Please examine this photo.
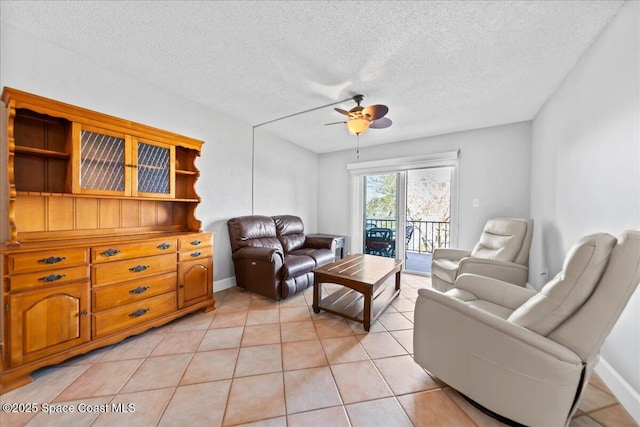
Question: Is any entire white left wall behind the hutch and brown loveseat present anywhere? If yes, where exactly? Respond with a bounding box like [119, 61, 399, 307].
[0, 23, 318, 290]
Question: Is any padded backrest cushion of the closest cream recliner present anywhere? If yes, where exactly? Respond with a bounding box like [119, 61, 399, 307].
[509, 233, 616, 336]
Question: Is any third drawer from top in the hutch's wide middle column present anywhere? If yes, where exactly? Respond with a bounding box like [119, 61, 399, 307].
[91, 273, 176, 313]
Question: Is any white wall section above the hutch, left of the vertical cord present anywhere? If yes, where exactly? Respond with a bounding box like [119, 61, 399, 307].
[0, 23, 252, 290]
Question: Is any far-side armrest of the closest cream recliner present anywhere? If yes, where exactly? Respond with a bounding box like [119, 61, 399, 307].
[454, 273, 537, 310]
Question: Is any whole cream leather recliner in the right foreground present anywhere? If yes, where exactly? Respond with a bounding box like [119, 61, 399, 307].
[413, 231, 640, 427]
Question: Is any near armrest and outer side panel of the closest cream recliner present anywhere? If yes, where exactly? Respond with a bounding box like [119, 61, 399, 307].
[413, 289, 585, 426]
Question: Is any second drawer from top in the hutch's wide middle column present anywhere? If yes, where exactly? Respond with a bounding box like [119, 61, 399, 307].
[91, 253, 177, 286]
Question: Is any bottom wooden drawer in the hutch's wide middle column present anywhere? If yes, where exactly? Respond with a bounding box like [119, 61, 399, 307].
[92, 292, 176, 338]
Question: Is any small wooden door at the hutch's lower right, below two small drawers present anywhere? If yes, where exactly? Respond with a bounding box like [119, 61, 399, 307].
[178, 258, 213, 308]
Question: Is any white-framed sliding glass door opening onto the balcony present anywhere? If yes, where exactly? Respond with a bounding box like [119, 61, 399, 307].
[347, 151, 460, 275]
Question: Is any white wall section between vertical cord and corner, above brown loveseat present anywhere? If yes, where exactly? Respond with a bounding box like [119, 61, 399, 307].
[254, 126, 318, 234]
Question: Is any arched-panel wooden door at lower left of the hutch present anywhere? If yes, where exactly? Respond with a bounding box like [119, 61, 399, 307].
[9, 281, 89, 366]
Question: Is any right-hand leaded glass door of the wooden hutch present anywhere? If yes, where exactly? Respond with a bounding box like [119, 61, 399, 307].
[134, 141, 175, 197]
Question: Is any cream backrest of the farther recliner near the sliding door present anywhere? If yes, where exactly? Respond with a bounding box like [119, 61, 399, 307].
[471, 218, 533, 266]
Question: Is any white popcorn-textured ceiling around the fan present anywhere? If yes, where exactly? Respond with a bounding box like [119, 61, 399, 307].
[0, 0, 623, 153]
